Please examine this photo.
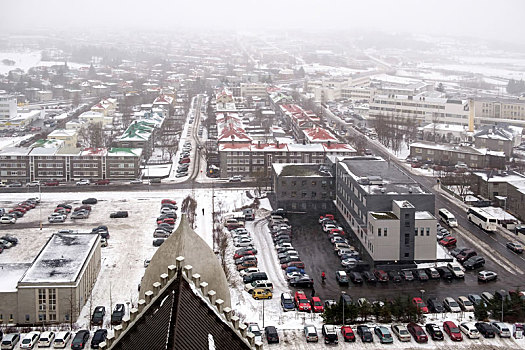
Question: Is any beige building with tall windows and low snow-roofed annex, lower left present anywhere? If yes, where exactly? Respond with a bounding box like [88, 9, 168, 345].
[0, 234, 101, 325]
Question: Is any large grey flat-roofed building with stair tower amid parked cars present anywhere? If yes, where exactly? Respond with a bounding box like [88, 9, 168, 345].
[335, 156, 436, 263]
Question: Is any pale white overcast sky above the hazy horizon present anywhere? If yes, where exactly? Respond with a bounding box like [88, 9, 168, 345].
[4, 0, 525, 41]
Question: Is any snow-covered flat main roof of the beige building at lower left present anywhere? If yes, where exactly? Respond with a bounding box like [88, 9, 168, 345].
[20, 233, 99, 283]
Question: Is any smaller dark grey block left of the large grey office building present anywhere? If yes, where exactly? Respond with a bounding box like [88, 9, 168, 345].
[272, 163, 335, 213]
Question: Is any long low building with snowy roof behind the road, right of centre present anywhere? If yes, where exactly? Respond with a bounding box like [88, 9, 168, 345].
[410, 141, 505, 169]
